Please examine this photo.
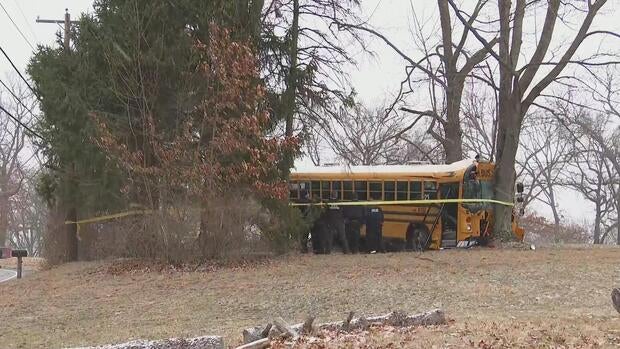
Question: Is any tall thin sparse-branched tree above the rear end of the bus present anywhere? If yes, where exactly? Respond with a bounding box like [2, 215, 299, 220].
[259, 0, 364, 171]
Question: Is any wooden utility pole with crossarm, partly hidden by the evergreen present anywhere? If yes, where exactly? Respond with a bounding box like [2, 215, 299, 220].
[37, 9, 79, 261]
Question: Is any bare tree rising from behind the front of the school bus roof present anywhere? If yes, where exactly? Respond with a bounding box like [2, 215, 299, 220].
[338, 0, 497, 162]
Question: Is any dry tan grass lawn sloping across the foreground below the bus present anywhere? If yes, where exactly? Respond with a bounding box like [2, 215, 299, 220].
[0, 248, 620, 348]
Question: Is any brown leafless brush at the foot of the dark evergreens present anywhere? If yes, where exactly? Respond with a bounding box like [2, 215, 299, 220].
[44, 192, 309, 264]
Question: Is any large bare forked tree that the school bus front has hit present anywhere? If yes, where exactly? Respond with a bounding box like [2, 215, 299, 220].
[447, 0, 608, 233]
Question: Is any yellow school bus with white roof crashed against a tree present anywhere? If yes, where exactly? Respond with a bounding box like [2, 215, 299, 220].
[290, 159, 524, 249]
